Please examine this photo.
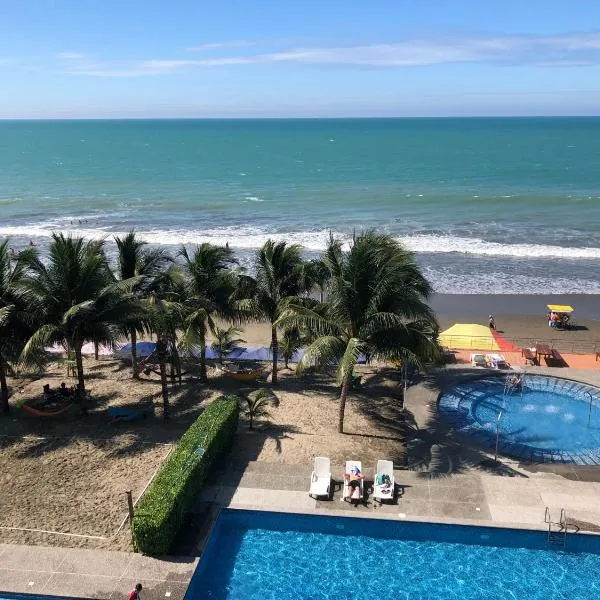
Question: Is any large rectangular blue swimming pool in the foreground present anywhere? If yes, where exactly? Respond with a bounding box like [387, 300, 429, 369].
[185, 510, 600, 600]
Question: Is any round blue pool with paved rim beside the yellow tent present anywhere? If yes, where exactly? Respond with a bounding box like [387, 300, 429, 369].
[438, 375, 600, 465]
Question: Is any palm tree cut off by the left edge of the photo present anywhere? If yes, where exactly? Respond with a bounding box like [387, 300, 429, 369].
[0, 240, 35, 413]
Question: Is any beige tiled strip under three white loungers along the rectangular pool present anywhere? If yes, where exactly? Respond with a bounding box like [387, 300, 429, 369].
[200, 462, 600, 531]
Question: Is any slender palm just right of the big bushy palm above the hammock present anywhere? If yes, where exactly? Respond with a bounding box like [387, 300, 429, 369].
[115, 230, 169, 379]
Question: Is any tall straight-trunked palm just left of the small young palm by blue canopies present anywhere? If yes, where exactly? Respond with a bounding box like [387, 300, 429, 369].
[179, 243, 238, 380]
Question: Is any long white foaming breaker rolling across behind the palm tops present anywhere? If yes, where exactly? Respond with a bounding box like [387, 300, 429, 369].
[0, 223, 600, 260]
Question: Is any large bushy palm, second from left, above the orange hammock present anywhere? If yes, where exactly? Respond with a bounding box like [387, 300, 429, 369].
[22, 233, 141, 399]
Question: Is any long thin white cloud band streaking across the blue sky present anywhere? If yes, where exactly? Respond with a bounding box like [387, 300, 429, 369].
[63, 32, 600, 77]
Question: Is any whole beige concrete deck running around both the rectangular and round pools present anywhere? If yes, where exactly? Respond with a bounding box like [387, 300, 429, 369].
[0, 366, 600, 600]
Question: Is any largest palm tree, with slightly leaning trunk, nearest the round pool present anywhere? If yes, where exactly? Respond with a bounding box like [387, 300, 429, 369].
[278, 231, 438, 433]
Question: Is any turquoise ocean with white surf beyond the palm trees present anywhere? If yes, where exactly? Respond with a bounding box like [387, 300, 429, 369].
[0, 118, 600, 294]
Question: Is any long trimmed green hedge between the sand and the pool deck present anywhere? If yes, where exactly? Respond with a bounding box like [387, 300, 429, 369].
[132, 396, 239, 556]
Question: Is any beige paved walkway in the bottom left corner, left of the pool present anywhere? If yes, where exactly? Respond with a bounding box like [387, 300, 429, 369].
[0, 544, 198, 600]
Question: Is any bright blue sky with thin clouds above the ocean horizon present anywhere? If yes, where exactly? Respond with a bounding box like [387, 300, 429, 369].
[0, 0, 600, 118]
